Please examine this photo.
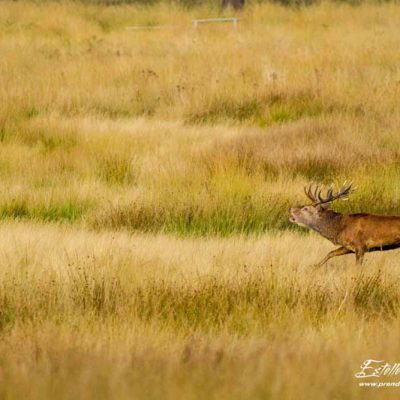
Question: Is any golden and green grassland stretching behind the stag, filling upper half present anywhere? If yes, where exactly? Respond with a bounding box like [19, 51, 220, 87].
[0, 2, 400, 234]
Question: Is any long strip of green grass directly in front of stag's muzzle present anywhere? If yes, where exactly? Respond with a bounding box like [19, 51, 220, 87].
[90, 196, 293, 236]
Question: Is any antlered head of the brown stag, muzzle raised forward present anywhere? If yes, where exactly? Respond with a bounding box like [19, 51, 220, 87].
[289, 183, 353, 232]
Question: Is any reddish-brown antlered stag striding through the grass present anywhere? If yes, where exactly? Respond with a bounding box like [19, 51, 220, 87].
[289, 184, 400, 266]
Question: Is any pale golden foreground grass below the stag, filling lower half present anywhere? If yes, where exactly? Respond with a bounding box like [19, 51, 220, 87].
[0, 222, 400, 399]
